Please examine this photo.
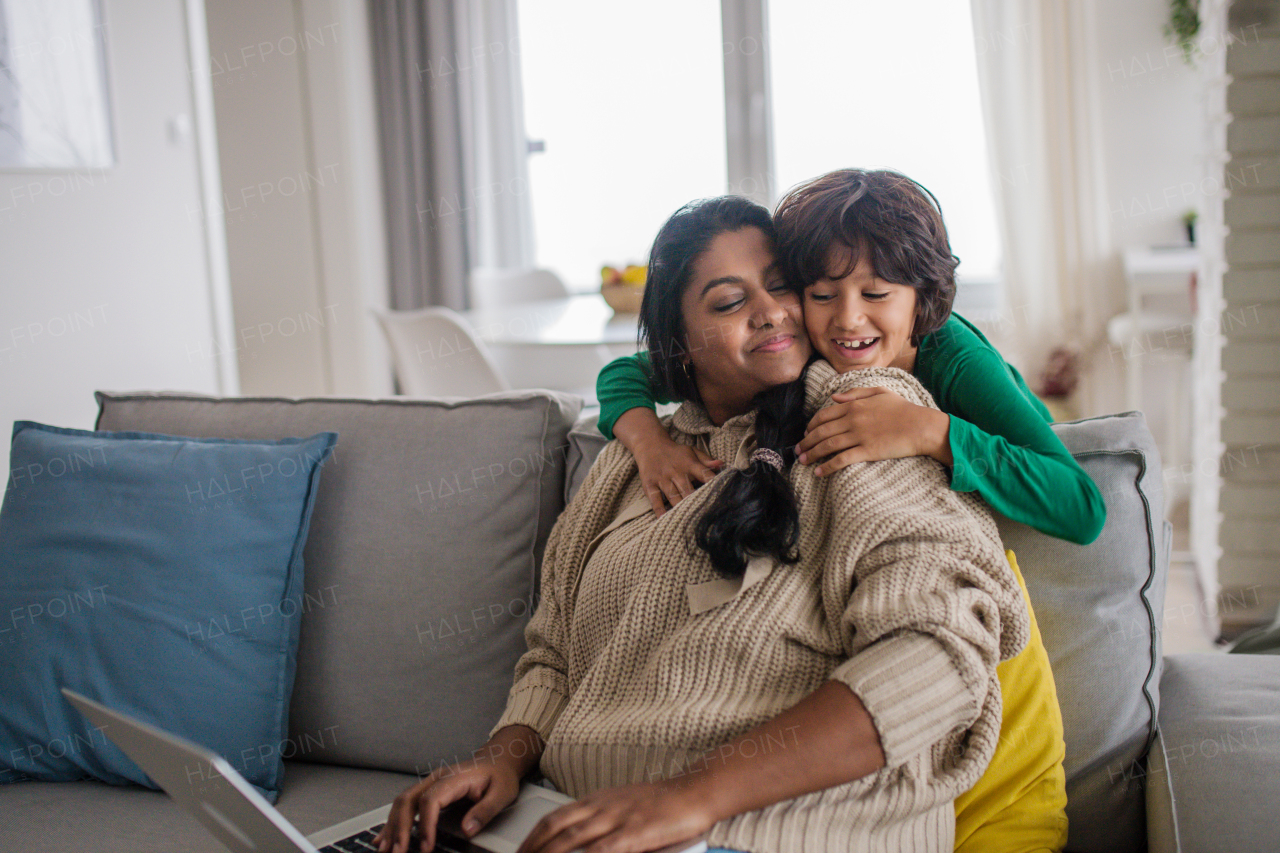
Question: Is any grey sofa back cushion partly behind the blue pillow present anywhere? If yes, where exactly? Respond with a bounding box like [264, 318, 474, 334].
[99, 392, 580, 774]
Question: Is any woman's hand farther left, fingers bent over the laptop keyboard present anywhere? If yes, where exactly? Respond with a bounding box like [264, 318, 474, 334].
[374, 758, 520, 853]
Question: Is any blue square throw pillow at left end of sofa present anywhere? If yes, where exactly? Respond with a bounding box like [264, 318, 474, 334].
[0, 421, 338, 802]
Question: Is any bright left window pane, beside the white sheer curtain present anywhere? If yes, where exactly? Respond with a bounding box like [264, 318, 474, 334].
[517, 0, 727, 289]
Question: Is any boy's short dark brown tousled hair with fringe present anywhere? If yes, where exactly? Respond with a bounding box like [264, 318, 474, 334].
[773, 169, 960, 346]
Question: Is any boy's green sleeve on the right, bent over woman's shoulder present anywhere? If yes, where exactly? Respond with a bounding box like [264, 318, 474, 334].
[931, 322, 1107, 544]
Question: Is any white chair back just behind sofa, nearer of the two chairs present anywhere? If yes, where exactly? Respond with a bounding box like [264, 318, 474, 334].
[374, 307, 509, 397]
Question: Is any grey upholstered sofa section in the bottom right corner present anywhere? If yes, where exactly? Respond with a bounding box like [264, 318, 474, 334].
[1146, 653, 1280, 853]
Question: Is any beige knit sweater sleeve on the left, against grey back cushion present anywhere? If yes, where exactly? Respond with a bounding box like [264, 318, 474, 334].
[489, 442, 635, 740]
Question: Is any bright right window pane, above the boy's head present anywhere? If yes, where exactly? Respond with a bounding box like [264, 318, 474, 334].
[769, 0, 1000, 285]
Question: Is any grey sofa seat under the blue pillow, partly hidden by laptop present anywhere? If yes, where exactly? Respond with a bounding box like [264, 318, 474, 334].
[0, 761, 417, 853]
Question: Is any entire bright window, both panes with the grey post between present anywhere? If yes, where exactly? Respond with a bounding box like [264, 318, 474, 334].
[517, 0, 1000, 302]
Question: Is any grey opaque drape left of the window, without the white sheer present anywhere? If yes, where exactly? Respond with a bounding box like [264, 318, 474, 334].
[369, 0, 476, 311]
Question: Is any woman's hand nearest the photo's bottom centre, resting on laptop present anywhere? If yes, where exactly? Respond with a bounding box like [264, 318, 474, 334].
[516, 781, 716, 853]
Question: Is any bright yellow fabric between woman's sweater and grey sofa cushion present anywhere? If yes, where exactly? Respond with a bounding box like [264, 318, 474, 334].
[956, 551, 1066, 853]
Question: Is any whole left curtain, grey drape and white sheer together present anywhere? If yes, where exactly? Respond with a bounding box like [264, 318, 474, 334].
[369, 0, 534, 310]
